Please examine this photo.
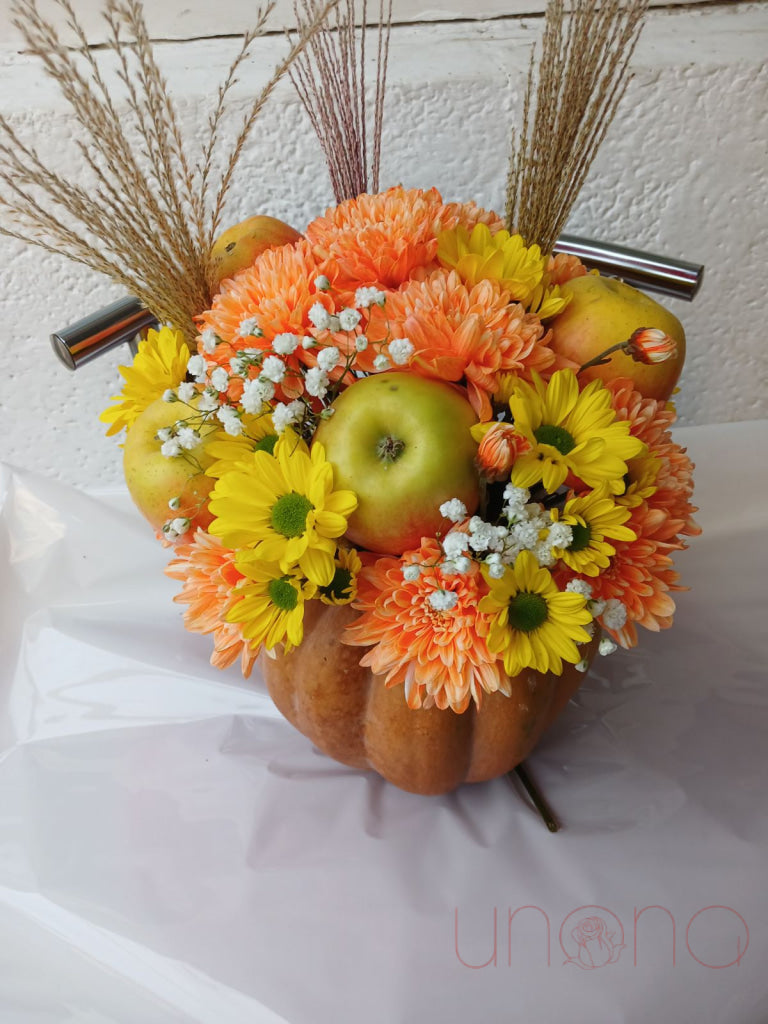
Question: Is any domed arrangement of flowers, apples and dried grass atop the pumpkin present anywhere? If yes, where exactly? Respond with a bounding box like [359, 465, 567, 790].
[0, 0, 698, 815]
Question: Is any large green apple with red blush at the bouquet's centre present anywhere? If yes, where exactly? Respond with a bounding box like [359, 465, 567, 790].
[314, 372, 480, 555]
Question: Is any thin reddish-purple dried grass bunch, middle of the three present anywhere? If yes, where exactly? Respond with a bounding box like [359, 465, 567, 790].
[290, 0, 392, 203]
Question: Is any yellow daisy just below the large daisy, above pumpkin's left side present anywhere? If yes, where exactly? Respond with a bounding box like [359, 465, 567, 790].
[226, 551, 317, 652]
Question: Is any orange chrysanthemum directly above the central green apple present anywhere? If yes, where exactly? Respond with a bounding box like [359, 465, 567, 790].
[366, 269, 555, 420]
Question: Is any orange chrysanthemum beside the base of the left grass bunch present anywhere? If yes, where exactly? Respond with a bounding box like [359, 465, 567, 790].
[199, 239, 323, 367]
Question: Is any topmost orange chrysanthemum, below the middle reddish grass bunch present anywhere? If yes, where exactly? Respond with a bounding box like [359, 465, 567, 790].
[306, 185, 503, 293]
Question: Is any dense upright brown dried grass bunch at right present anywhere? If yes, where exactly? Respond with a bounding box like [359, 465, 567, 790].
[507, 0, 648, 252]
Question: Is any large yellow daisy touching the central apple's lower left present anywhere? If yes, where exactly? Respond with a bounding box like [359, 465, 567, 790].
[209, 430, 357, 587]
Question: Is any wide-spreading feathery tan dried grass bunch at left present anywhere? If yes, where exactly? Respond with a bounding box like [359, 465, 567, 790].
[0, 0, 339, 337]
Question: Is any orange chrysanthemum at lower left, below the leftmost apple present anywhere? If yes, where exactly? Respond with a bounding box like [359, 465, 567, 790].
[165, 529, 258, 679]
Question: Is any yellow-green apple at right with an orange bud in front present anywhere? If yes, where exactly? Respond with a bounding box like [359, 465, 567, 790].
[551, 273, 685, 401]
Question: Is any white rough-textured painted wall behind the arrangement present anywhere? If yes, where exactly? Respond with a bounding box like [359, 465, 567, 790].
[0, 3, 768, 486]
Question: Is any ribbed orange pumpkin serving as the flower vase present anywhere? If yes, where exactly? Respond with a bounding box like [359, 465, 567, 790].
[261, 601, 598, 795]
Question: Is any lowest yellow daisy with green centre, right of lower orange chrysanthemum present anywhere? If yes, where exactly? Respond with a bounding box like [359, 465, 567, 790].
[478, 551, 592, 677]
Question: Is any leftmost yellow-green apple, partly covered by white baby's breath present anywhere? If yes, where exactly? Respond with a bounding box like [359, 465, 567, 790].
[123, 398, 217, 530]
